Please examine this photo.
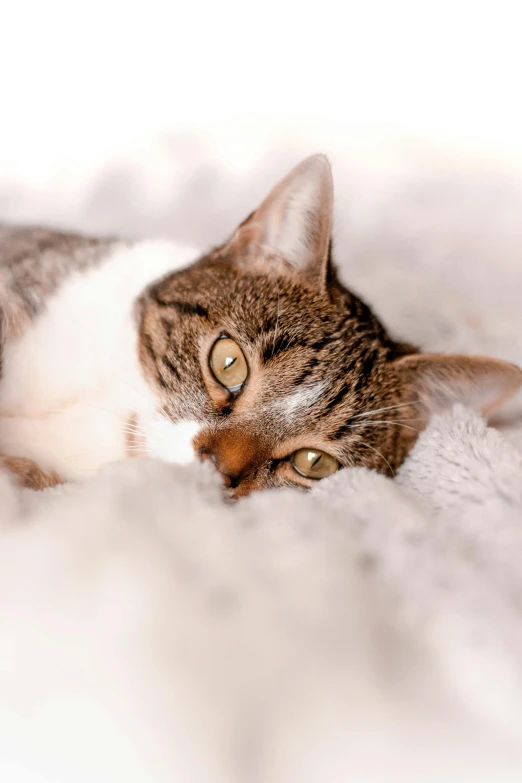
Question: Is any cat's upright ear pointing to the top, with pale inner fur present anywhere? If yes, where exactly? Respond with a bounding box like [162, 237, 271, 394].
[227, 155, 333, 288]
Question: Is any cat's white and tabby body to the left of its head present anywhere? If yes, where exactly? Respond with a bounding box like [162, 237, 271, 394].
[0, 226, 198, 478]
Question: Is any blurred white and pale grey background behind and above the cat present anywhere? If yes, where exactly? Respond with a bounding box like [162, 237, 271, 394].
[0, 0, 522, 361]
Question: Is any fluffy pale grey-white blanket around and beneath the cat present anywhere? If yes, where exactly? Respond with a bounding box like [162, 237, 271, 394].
[0, 136, 522, 783]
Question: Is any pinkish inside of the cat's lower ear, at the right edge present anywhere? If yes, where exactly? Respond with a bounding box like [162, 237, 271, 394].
[395, 354, 522, 415]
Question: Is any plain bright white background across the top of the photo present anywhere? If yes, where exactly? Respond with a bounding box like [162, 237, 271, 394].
[0, 0, 522, 187]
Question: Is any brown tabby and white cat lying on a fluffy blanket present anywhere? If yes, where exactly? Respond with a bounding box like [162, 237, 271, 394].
[0, 155, 522, 499]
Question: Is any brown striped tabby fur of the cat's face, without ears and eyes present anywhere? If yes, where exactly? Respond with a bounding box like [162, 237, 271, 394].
[140, 249, 418, 495]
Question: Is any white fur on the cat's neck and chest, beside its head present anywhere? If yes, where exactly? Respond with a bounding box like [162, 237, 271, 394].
[0, 241, 198, 480]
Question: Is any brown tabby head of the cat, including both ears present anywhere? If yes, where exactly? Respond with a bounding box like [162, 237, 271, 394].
[140, 155, 522, 497]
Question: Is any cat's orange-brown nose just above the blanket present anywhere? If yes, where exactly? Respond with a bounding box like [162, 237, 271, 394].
[198, 429, 265, 489]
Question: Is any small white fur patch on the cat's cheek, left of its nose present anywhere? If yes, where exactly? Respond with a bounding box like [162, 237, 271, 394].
[144, 416, 201, 465]
